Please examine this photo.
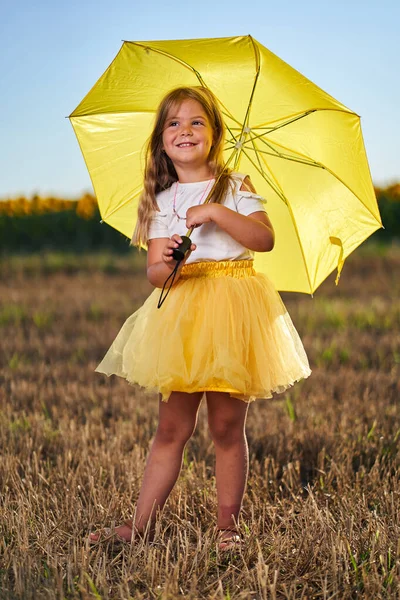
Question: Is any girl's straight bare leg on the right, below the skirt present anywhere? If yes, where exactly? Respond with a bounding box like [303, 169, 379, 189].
[207, 392, 249, 537]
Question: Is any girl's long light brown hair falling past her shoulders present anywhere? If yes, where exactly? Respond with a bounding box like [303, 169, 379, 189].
[131, 86, 231, 247]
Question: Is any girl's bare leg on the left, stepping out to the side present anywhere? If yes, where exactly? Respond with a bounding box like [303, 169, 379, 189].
[90, 392, 203, 541]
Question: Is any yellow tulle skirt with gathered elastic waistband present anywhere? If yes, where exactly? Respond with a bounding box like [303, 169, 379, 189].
[96, 260, 311, 402]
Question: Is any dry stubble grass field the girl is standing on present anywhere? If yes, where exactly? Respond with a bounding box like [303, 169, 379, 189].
[0, 249, 400, 600]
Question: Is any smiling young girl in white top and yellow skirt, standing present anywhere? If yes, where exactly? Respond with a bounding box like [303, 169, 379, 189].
[89, 87, 310, 550]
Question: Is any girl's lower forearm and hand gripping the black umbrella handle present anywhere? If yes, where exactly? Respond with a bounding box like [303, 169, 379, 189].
[147, 233, 196, 288]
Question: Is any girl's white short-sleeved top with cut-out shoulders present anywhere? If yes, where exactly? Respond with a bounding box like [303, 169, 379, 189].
[149, 173, 266, 264]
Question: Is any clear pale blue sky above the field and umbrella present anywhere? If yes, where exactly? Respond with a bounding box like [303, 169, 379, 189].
[0, 0, 400, 198]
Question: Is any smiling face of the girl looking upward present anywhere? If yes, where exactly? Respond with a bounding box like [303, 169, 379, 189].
[162, 100, 213, 169]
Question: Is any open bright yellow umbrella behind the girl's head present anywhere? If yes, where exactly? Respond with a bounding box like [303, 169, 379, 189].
[70, 36, 382, 293]
